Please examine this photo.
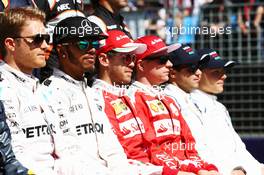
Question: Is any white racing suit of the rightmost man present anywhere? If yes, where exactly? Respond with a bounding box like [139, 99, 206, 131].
[191, 90, 261, 175]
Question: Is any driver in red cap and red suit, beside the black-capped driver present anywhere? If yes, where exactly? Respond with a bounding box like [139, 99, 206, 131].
[92, 30, 168, 174]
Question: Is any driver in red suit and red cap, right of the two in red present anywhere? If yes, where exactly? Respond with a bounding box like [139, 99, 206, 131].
[122, 36, 220, 175]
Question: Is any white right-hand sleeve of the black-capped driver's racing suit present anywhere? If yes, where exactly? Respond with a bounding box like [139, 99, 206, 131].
[89, 89, 162, 175]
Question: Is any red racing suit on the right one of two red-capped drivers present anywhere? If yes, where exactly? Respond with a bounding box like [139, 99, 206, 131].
[124, 82, 217, 173]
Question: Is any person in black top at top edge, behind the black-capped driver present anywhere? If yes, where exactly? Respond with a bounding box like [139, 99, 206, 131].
[91, 0, 132, 38]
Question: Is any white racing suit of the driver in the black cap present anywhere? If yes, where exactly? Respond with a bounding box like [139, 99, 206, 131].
[41, 69, 162, 175]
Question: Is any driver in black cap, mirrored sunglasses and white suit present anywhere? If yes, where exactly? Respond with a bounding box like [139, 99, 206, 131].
[41, 17, 160, 175]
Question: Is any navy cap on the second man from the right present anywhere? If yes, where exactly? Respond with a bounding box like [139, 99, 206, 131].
[169, 45, 208, 67]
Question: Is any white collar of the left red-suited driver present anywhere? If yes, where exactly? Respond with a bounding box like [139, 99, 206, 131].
[92, 79, 126, 97]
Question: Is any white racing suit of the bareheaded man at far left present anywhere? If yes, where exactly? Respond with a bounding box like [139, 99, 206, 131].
[0, 62, 54, 175]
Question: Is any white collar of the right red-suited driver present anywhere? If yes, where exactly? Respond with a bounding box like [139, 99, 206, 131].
[131, 81, 165, 99]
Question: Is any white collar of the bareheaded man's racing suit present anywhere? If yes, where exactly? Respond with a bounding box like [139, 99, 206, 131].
[0, 61, 39, 92]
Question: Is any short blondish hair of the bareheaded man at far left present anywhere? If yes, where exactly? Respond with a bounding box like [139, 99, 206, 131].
[0, 7, 45, 57]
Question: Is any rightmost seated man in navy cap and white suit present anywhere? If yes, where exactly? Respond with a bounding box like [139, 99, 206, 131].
[191, 49, 263, 175]
